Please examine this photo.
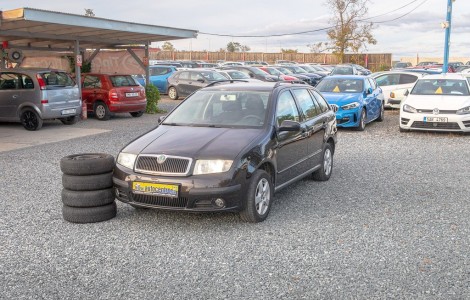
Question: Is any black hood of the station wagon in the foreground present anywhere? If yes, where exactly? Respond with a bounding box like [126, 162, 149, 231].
[122, 125, 262, 159]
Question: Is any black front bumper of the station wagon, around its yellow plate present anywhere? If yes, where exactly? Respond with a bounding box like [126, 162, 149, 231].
[113, 164, 246, 212]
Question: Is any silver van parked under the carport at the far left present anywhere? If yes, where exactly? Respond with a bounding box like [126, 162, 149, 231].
[0, 68, 82, 131]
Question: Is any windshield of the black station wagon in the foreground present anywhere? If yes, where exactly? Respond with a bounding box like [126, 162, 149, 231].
[163, 90, 270, 128]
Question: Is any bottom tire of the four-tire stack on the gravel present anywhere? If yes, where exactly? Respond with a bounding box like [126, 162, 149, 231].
[62, 202, 117, 223]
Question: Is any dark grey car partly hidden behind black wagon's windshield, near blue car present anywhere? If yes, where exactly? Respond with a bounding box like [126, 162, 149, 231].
[168, 69, 227, 100]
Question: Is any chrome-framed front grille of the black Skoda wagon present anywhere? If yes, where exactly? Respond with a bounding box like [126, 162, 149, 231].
[135, 155, 192, 176]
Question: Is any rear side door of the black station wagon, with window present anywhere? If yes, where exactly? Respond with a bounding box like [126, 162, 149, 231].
[292, 88, 327, 168]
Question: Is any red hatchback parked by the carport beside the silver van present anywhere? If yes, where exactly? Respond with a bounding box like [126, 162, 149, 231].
[82, 73, 147, 121]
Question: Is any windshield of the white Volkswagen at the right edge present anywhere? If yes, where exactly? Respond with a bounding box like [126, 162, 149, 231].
[411, 79, 469, 96]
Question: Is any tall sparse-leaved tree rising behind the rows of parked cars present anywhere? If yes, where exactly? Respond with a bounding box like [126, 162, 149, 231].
[309, 0, 377, 62]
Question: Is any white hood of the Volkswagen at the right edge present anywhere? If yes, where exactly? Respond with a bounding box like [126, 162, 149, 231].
[404, 95, 470, 110]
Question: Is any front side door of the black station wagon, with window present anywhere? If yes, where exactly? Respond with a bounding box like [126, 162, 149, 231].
[276, 90, 309, 186]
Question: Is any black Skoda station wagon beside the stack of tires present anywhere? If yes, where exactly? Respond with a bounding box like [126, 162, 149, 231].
[113, 82, 336, 222]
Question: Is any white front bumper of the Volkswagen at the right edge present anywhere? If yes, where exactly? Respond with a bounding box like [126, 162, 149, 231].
[400, 110, 470, 132]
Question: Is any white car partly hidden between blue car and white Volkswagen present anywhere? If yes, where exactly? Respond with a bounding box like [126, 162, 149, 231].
[372, 71, 424, 108]
